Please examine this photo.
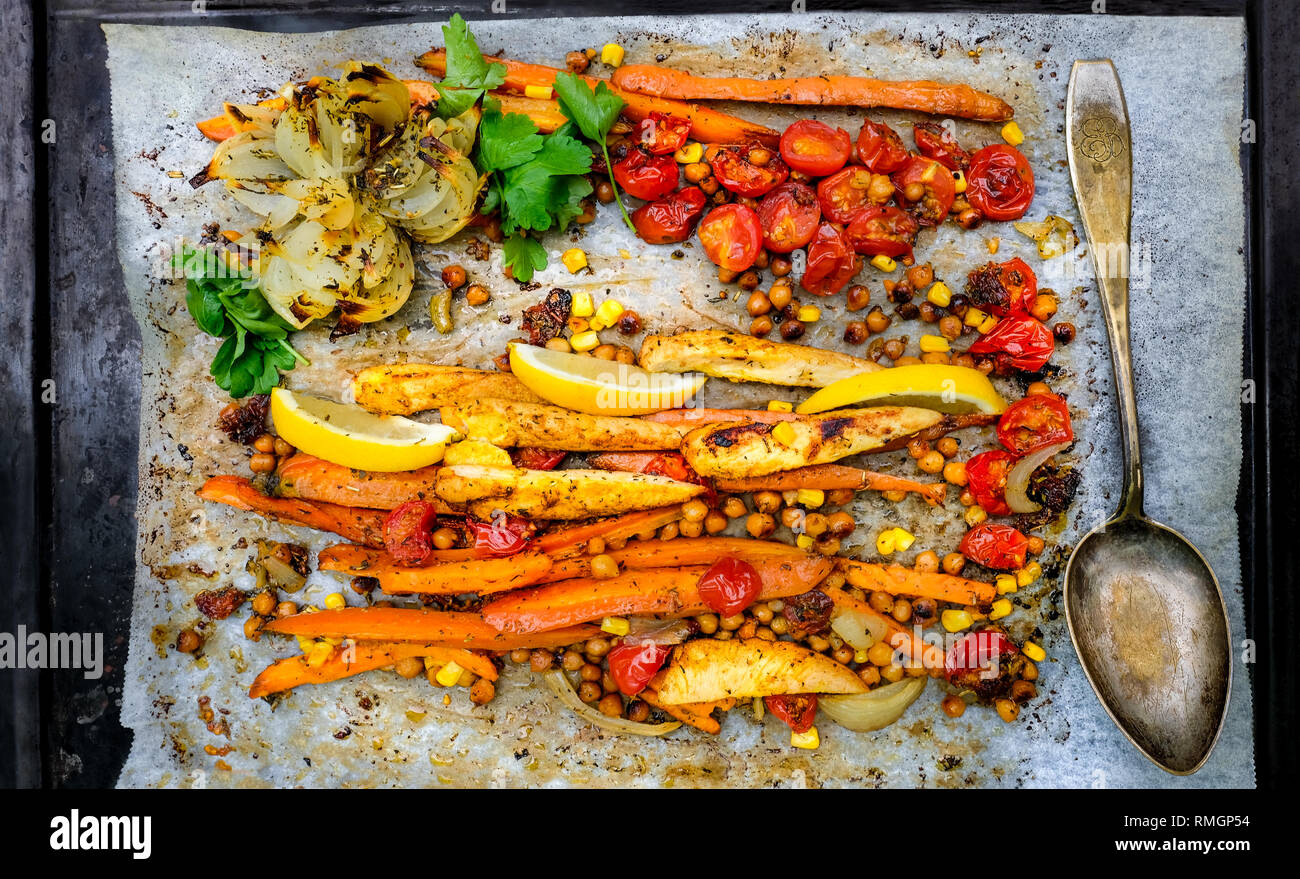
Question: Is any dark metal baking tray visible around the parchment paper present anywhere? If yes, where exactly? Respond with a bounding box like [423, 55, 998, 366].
[0, 0, 1300, 787]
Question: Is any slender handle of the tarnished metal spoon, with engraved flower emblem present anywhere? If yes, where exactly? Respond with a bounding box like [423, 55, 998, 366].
[1065, 60, 1143, 515]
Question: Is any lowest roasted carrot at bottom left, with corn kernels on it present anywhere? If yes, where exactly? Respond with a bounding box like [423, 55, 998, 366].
[248, 641, 498, 698]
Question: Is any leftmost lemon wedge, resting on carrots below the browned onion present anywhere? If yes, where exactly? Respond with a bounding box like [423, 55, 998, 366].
[270, 387, 460, 473]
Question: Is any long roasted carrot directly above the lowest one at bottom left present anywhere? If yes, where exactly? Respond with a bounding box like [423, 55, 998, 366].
[263, 607, 601, 651]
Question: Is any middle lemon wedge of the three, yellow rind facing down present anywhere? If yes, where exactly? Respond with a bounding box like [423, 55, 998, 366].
[510, 342, 707, 415]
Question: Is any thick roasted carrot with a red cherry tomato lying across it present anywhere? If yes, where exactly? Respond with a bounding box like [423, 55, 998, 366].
[482, 555, 832, 633]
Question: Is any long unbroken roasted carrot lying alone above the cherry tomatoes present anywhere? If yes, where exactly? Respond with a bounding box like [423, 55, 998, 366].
[612, 64, 1015, 122]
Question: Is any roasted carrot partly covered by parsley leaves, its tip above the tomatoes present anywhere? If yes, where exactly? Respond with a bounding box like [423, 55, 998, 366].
[415, 49, 781, 146]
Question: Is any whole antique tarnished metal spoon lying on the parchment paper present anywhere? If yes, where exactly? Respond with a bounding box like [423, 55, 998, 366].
[1065, 61, 1232, 775]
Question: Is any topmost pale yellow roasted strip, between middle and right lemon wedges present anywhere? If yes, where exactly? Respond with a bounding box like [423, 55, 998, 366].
[638, 330, 884, 387]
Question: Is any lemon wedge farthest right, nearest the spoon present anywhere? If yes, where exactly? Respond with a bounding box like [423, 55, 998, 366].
[794, 363, 1006, 415]
